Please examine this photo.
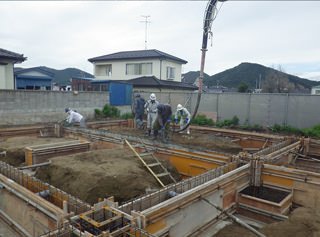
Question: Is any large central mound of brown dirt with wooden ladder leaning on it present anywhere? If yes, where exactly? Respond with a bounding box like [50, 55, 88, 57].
[36, 149, 180, 204]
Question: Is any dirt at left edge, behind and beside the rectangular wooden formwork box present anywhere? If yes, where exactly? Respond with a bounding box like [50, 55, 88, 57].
[0, 136, 74, 166]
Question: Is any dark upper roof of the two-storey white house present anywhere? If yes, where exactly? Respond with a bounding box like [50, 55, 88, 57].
[88, 49, 187, 64]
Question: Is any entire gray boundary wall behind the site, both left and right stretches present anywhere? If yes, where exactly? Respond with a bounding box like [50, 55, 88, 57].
[0, 90, 320, 129]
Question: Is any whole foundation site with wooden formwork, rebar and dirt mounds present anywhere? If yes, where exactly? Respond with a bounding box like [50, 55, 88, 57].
[0, 119, 320, 236]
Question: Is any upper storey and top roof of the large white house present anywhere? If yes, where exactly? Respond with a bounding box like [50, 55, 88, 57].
[88, 49, 187, 82]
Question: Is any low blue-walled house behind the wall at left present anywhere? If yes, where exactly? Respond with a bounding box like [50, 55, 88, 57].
[14, 67, 54, 90]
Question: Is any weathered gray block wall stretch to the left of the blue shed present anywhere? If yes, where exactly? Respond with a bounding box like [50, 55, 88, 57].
[0, 90, 111, 126]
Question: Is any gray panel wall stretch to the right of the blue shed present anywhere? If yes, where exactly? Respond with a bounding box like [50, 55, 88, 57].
[140, 92, 320, 129]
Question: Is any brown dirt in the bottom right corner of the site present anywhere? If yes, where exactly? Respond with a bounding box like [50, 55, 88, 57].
[215, 207, 320, 237]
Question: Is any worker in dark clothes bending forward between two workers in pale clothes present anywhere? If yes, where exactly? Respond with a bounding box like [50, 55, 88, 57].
[153, 104, 172, 141]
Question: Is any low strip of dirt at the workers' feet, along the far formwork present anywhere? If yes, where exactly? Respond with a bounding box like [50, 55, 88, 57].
[104, 128, 242, 154]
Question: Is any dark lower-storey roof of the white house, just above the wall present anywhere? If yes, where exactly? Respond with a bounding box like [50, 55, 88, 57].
[122, 76, 198, 90]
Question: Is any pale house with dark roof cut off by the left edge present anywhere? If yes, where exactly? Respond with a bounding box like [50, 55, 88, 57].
[0, 48, 27, 90]
